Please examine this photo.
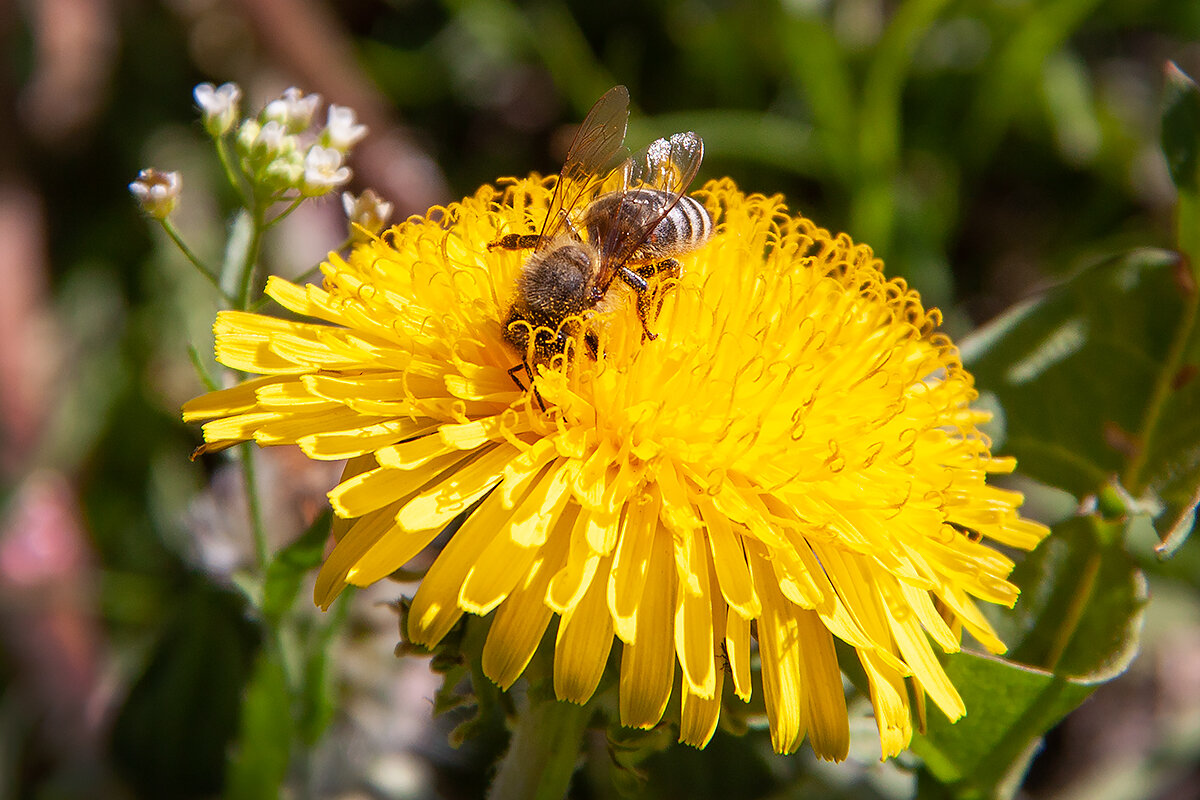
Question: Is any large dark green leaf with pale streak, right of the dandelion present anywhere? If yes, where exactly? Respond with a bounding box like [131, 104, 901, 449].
[962, 249, 1200, 554]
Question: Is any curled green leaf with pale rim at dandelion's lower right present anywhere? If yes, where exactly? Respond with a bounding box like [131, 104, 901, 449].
[913, 517, 1147, 798]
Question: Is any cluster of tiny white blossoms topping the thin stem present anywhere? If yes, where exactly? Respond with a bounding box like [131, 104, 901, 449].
[194, 83, 367, 199]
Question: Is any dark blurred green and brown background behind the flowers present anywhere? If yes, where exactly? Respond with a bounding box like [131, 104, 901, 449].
[0, 0, 1200, 799]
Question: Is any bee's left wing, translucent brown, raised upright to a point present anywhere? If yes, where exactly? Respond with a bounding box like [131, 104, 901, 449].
[538, 86, 629, 249]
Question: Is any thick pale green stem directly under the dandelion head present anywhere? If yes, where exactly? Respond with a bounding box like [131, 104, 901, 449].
[487, 699, 592, 800]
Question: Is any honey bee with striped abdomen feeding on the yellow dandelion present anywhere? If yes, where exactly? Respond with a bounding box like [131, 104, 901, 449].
[488, 86, 713, 376]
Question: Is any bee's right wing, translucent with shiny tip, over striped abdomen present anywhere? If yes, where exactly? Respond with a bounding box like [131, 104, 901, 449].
[596, 131, 704, 287]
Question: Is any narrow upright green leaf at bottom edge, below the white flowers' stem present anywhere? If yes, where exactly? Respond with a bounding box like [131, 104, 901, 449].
[224, 651, 294, 800]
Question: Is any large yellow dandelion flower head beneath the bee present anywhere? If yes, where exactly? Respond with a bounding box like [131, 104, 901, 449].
[184, 178, 1046, 759]
